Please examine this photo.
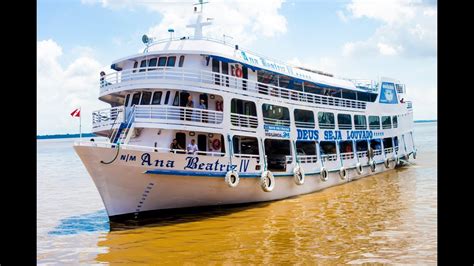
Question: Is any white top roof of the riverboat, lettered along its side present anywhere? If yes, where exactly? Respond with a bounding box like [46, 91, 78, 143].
[112, 37, 375, 92]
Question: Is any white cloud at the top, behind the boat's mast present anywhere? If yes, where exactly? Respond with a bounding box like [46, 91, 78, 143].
[82, 0, 287, 45]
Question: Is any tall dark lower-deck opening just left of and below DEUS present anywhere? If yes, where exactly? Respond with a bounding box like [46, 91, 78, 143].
[264, 139, 292, 171]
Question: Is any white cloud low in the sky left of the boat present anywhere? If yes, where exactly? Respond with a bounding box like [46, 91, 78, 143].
[36, 39, 108, 134]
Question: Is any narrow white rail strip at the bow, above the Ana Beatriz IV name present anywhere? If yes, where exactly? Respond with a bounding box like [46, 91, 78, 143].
[74, 141, 225, 157]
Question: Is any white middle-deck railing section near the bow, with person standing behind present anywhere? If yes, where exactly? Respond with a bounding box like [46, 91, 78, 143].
[135, 105, 224, 124]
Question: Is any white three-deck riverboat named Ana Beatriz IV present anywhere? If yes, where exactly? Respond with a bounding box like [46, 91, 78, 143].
[74, 3, 416, 220]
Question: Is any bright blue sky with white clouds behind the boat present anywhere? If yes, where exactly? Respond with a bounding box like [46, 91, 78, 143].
[37, 0, 437, 135]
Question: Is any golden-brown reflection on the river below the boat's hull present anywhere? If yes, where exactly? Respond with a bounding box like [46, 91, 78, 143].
[96, 166, 434, 264]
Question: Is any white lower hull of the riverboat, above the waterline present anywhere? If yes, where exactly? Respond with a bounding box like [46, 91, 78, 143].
[74, 143, 412, 220]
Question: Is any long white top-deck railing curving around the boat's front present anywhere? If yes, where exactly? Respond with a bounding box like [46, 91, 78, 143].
[100, 67, 366, 109]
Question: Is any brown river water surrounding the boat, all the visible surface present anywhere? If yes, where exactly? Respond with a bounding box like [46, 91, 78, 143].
[37, 123, 437, 265]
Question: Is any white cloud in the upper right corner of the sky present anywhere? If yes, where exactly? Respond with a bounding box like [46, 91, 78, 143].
[338, 0, 437, 57]
